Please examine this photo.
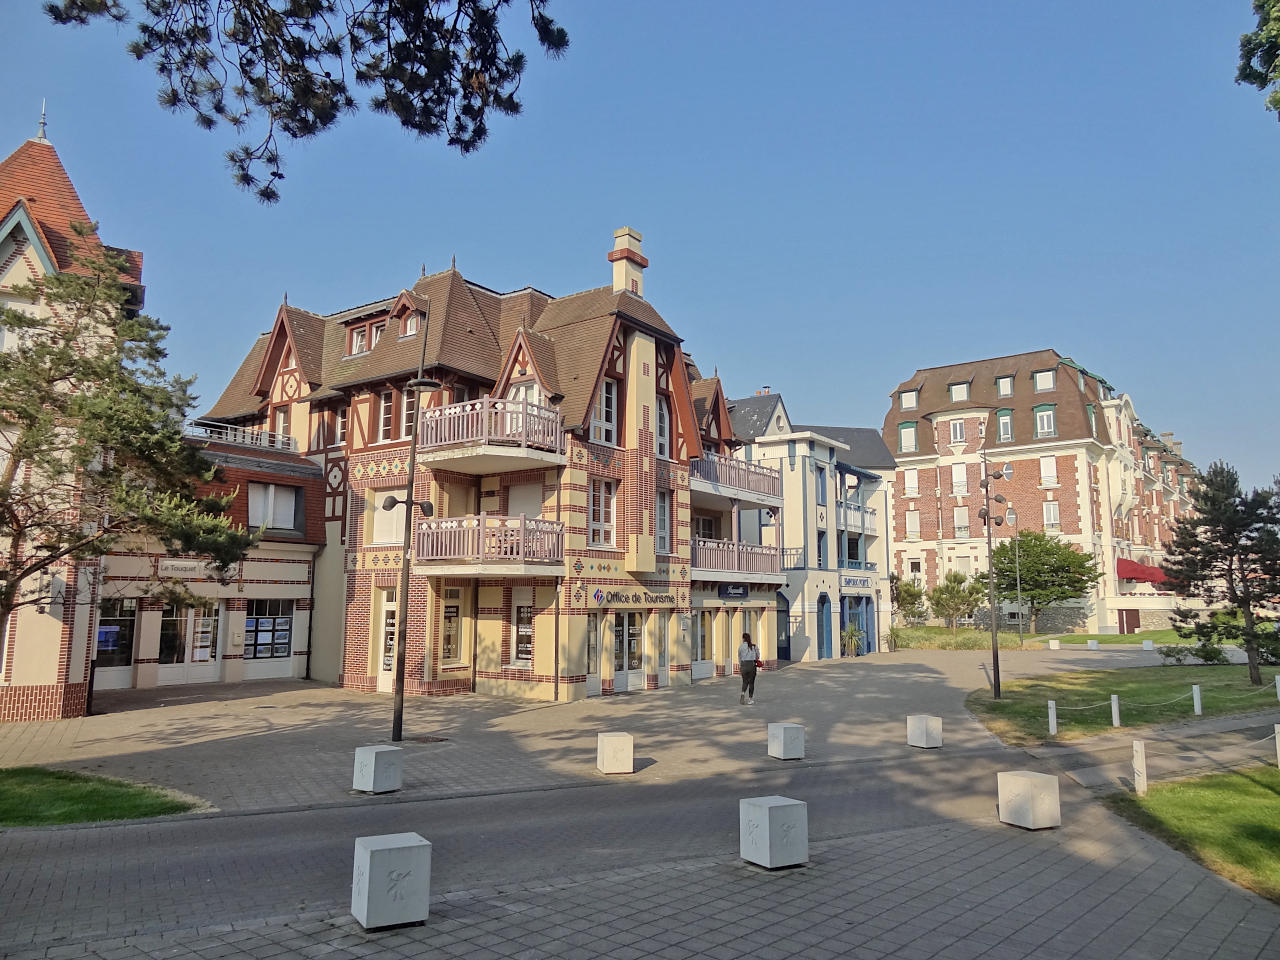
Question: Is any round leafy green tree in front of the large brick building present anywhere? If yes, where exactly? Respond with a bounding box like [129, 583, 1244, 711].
[978, 530, 1102, 634]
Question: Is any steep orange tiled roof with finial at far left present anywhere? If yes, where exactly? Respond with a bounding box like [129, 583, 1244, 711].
[0, 140, 142, 284]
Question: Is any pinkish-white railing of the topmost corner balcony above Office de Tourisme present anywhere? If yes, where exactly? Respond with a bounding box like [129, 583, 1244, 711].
[419, 397, 564, 453]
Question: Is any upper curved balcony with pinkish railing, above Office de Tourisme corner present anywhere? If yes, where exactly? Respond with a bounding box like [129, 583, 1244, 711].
[419, 397, 564, 474]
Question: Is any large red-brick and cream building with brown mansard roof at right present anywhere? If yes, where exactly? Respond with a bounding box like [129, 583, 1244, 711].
[883, 349, 1194, 632]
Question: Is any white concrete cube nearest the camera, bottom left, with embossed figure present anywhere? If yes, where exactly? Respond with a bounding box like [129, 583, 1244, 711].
[351, 833, 431, 928]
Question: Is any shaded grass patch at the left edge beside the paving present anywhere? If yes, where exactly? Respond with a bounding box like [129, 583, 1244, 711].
[0, 767, 196, 827]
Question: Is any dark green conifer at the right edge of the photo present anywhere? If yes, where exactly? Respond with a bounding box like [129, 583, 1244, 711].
[1164, 461, 1280, 685]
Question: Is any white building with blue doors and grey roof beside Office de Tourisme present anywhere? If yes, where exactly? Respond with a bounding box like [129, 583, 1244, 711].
[730, 388, 895, 660]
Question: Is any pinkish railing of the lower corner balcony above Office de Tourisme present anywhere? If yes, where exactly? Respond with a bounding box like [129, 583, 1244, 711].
[415, 513, 564, 563]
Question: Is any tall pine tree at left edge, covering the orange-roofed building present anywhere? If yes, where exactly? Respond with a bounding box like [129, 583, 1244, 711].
[0, 224, 252, 650]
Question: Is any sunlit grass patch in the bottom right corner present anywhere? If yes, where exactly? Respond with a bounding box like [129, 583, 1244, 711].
[1107, 767, 1280, 902]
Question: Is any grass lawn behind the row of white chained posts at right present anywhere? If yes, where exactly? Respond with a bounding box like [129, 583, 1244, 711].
[965, 664, 1280, 744]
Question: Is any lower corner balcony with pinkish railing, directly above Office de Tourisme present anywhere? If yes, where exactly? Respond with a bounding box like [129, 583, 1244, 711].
[413, 513, 564, 576]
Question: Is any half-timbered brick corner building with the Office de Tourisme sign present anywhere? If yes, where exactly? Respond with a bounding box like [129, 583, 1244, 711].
[209, 228, 781, 700]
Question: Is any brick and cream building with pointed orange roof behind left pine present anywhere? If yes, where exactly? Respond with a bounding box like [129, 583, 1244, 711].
[0, 131, 323, 721]
